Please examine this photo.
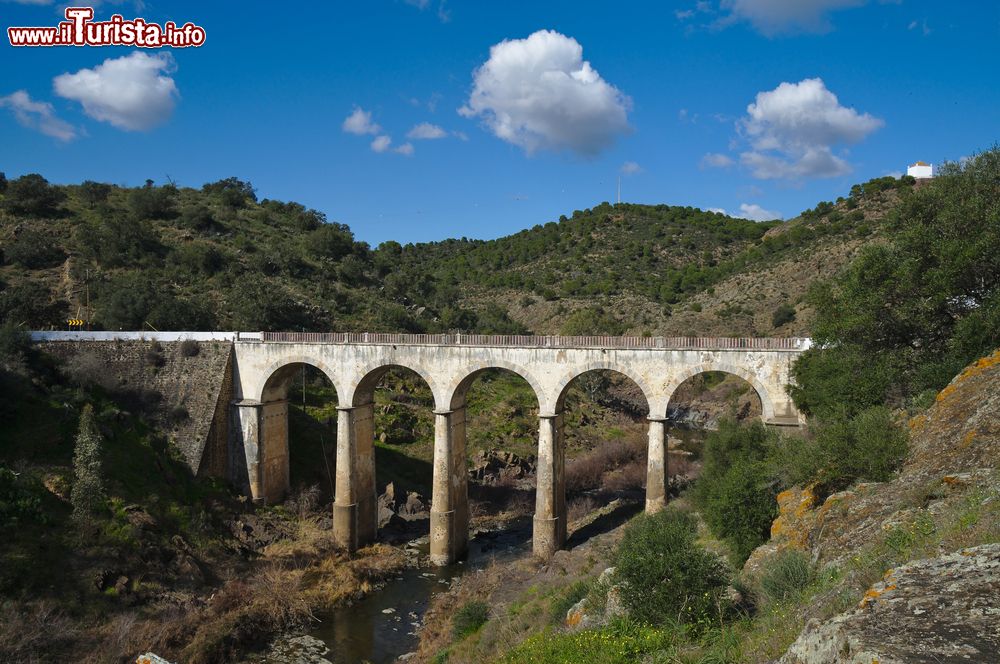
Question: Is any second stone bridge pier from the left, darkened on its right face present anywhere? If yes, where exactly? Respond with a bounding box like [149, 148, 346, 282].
[333, 403, 378, 552]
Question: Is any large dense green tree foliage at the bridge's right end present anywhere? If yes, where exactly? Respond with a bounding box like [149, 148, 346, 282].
[793, 148, 1000, 414]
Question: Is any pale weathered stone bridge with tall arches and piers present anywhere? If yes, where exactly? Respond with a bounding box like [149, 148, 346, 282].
[33, 332, 810, 564]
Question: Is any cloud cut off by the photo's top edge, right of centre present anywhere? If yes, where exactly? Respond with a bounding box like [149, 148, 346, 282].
[720, 0, 866, 36]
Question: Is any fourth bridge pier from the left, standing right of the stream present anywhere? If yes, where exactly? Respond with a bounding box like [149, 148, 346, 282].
[532, 413, 566, 560]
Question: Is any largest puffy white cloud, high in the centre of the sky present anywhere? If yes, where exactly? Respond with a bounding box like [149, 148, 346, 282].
[459, 30, 632, 155]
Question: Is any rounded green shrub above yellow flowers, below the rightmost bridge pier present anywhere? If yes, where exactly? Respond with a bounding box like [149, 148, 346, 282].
[615, 508, 728, 625]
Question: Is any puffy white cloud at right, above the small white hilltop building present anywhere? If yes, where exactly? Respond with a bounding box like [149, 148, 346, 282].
[739, 78, 885, 179]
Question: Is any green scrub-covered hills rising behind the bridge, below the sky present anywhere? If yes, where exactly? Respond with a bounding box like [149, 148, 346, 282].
[0, 175, 912, 335]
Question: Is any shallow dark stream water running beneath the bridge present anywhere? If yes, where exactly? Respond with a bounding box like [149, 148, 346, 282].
[310, 517, 531, 664]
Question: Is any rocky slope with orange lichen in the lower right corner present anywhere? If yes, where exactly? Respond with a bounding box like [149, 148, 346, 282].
[746, 351, 1000, 664]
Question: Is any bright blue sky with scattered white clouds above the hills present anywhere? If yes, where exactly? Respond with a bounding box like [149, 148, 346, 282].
[0, 0, 1000, 245]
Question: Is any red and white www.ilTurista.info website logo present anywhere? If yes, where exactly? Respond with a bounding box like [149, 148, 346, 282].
[7, 7, 205, 48]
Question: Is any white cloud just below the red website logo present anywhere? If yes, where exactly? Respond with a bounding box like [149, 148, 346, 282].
[52, 51, 179, 131]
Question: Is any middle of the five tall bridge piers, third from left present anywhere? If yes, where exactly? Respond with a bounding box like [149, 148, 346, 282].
[431, 408, 469, 565]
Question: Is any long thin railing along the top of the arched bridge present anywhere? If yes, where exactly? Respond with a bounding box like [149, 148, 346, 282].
[258, 332, 812, 351]
